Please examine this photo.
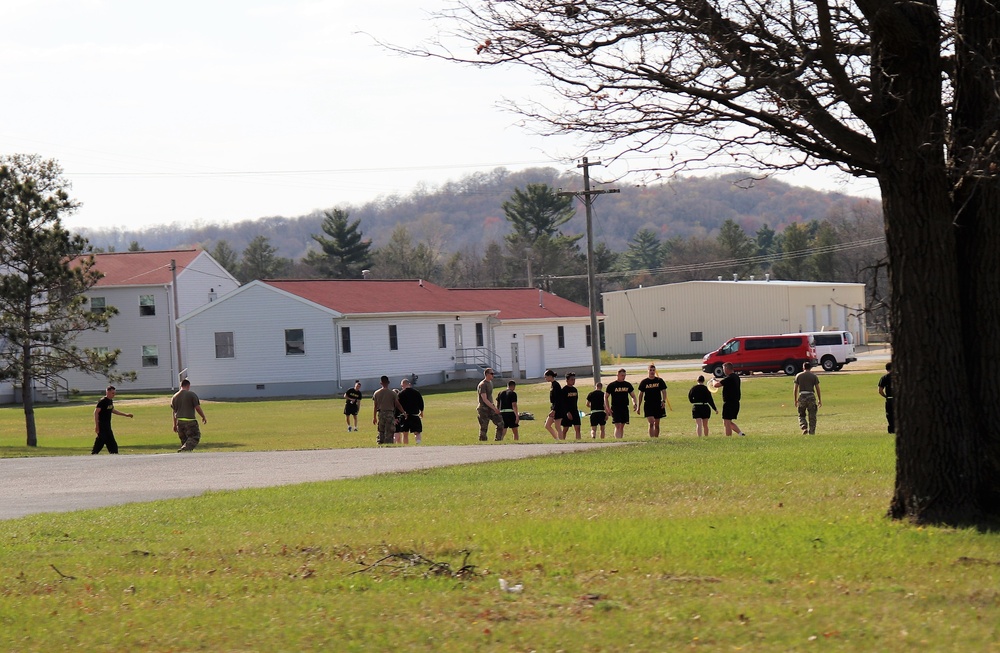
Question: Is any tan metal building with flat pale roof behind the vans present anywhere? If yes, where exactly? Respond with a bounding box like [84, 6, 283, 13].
[602, 279, 867, 358]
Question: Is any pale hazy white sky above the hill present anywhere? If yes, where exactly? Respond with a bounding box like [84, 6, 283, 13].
[0, 0, 870, 232]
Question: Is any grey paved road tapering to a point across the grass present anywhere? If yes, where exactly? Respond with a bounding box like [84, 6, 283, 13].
[0, 442, 614, 519]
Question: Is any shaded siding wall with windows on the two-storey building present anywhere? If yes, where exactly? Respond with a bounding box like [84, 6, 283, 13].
[62, 286, 177, 392]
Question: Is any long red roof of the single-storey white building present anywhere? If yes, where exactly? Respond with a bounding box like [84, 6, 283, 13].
[263, 279, 590, 320]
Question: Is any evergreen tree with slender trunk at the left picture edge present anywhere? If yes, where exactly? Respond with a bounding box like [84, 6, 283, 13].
[0, 155, 134, 447]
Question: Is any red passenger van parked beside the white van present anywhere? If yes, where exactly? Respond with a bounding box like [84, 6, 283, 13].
[701, 333, 817, 377]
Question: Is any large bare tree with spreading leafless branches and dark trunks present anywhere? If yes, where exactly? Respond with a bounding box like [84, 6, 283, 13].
[406, 0, 1000, 524]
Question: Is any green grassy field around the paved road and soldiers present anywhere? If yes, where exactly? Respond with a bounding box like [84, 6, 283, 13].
[0, 372, 1000, 651]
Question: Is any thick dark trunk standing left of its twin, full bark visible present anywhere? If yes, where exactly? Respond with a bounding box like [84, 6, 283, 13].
[871, 0, 981, 524]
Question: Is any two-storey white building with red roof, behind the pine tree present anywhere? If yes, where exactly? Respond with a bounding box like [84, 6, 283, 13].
[54, 249, 239, 392]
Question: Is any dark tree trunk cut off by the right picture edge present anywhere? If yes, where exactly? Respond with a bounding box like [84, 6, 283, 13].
[952, 0, 1000, 515]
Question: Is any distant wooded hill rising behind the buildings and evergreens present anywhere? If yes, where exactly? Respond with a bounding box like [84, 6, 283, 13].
[79, 168, 874, 260]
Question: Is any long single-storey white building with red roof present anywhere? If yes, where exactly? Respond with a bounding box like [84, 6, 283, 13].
[179, 280, 592, 398]
